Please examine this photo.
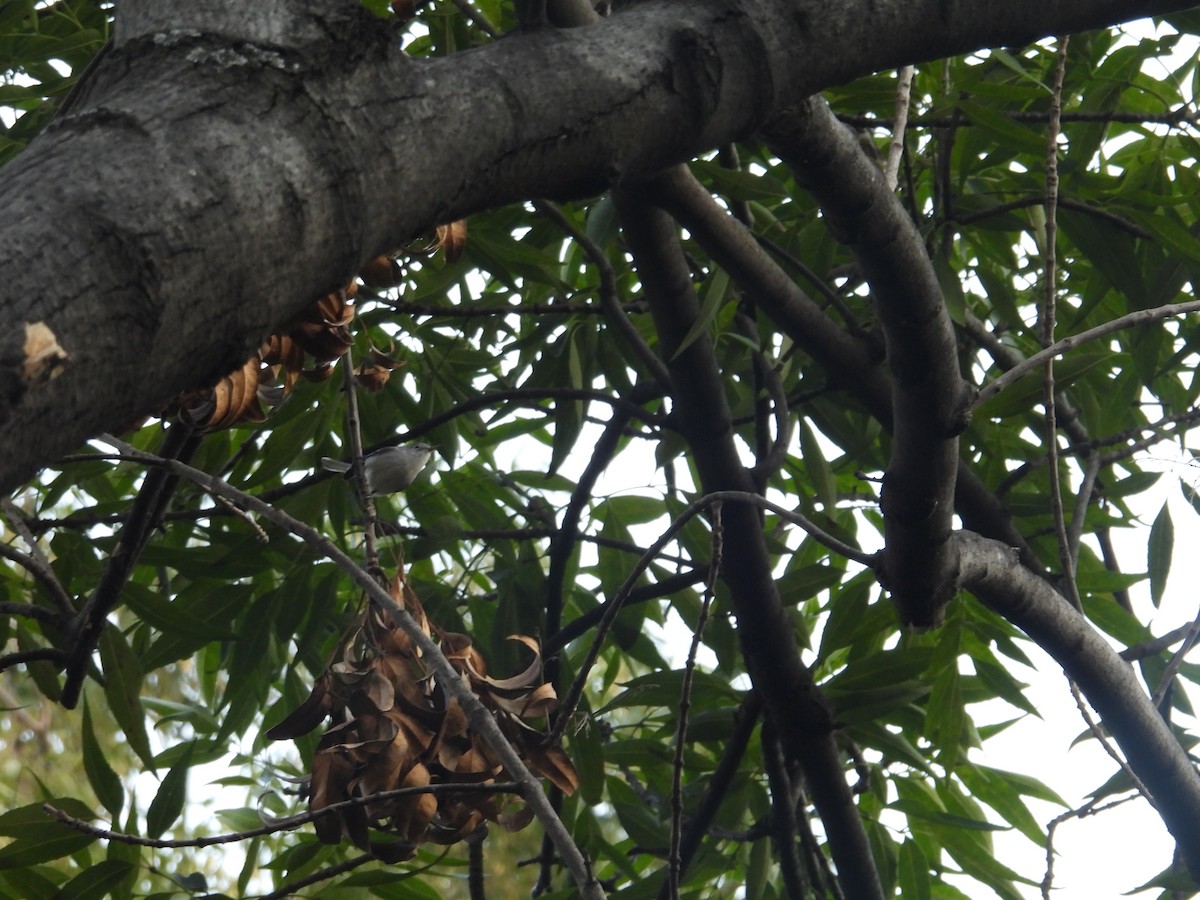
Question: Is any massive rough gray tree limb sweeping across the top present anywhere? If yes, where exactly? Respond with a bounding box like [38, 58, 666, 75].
[0, 0, 1192, 491]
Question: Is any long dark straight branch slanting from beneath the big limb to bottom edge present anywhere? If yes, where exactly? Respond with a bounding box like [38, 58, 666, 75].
[616, 192, 882, 898]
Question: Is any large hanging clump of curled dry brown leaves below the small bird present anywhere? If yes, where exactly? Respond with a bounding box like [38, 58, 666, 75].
[266, 575, 578, 862]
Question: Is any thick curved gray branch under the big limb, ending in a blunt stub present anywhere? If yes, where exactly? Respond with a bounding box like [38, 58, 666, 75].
[766, 97, 971, 625]
